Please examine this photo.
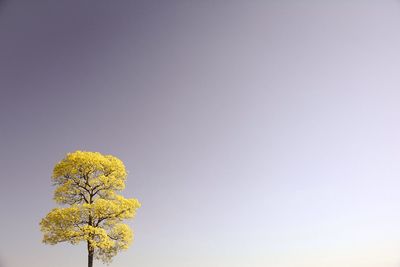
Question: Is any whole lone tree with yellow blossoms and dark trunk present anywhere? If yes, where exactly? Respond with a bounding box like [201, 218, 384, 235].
[40, 151, 141, 267]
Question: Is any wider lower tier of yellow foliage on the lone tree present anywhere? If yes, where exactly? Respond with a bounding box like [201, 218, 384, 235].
[40, 195, 140, 262]
